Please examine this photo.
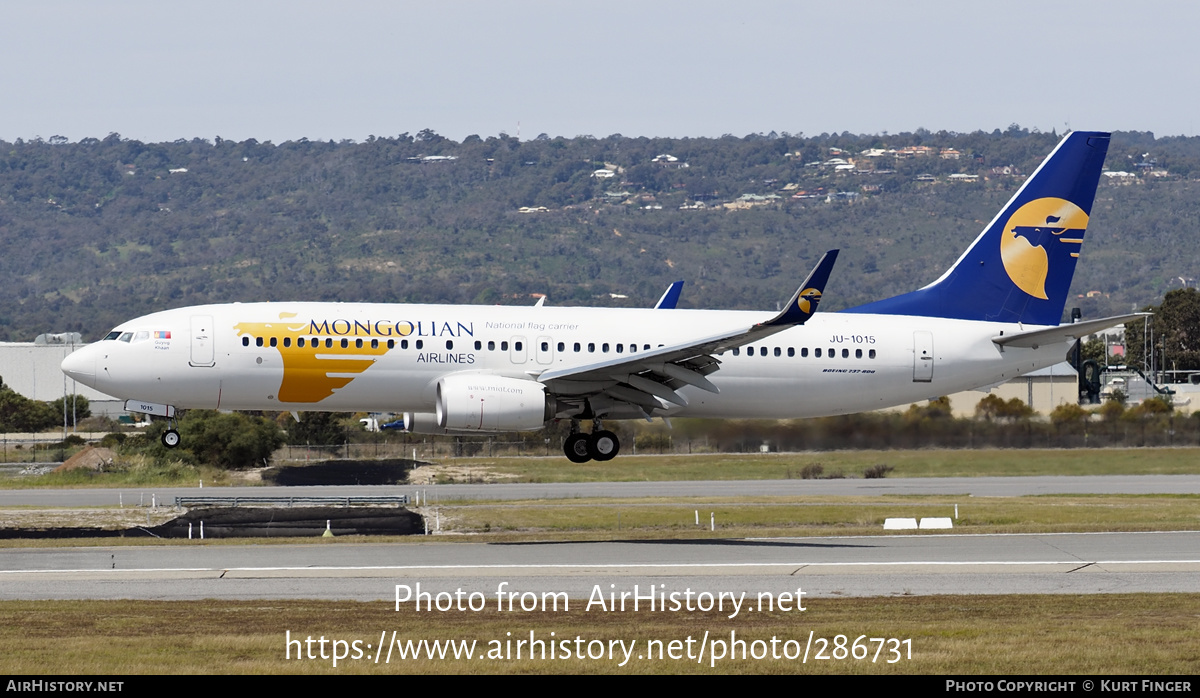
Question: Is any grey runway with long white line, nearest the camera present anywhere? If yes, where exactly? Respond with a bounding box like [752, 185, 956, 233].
[0, 531, 1200, 601]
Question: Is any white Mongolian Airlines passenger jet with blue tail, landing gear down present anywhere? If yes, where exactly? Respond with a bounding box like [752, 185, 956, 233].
[62, 131, 1142, 463]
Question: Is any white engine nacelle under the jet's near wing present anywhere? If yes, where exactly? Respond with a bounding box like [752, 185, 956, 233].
[437, 373, 553, 432]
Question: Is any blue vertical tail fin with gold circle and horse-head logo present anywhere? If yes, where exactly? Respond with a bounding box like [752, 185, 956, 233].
[845, 131, 1109, 325]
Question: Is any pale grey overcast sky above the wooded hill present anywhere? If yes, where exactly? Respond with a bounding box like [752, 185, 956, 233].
[0, 0, 1200, 143]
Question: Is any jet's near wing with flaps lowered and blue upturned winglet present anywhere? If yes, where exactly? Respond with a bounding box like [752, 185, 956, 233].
[538, 249, 838, 417]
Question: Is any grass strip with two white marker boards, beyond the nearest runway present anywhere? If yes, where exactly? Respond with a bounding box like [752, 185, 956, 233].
[437, 495, 1200, 538]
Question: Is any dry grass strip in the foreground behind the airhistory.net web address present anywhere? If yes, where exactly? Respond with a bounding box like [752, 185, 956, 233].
[0, 594, 1200, 676]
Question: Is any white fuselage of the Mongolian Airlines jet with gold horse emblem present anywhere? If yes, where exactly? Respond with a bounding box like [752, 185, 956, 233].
[64, 302, 1069, 419]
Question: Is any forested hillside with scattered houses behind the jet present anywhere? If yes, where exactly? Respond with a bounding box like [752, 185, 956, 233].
[0, 126, 1200, 341]
